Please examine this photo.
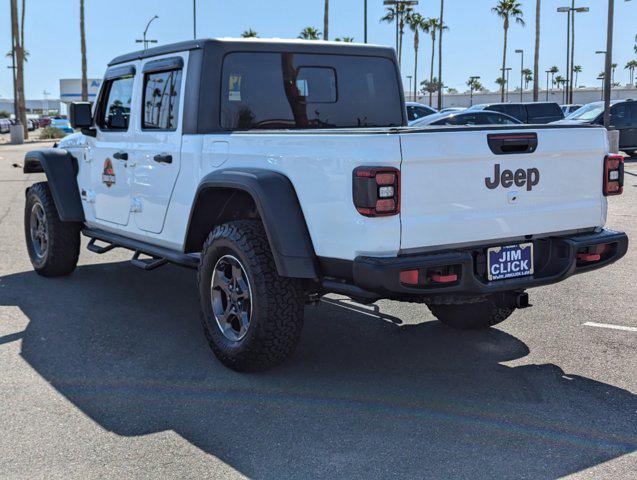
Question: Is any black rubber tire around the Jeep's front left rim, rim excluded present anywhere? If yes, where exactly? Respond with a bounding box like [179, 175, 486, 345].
[24, 182, 81, 277]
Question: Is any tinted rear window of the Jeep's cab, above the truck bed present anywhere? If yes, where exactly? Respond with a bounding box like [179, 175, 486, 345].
[221, 52, 402, 130]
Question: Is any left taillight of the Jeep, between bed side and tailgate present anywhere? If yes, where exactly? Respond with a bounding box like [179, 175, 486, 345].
[352, 167, 400, 217]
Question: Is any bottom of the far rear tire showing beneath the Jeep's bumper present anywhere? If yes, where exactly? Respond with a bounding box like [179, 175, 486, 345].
[429, 299, 515, 330]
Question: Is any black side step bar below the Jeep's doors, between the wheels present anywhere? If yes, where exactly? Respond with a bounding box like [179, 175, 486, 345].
[82, 228, 199, 270]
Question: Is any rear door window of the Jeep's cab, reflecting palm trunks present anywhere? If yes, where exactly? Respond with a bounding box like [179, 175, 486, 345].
[142, 70, 181, 130]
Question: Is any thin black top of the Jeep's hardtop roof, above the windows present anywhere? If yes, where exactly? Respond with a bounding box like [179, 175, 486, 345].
[108, 38, 395, 66]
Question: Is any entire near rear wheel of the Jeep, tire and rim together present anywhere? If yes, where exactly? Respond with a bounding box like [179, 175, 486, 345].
[198, 220, 304, 371]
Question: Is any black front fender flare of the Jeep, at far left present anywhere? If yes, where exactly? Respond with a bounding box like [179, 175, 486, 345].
[23, 148, 84, 222]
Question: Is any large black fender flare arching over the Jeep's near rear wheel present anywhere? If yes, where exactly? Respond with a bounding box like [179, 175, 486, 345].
[185, 168, 318, 279]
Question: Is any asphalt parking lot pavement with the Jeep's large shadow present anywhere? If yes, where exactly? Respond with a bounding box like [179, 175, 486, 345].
[0, 141, 637, 479]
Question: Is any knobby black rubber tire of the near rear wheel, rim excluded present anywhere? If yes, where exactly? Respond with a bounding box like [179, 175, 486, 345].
[197, 220, 304, 372]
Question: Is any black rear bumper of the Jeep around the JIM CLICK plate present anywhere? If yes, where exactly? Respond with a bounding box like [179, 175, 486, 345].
[353, 230, 628, 298]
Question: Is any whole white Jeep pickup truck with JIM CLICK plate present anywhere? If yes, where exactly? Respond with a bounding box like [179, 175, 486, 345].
[24, 40, 628, 371]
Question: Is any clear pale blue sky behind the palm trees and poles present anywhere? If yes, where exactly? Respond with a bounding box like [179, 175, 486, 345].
[0, 0, 637, 99]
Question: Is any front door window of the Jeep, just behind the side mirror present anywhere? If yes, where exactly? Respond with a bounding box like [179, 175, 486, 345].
[98, 76, 133, 130]
